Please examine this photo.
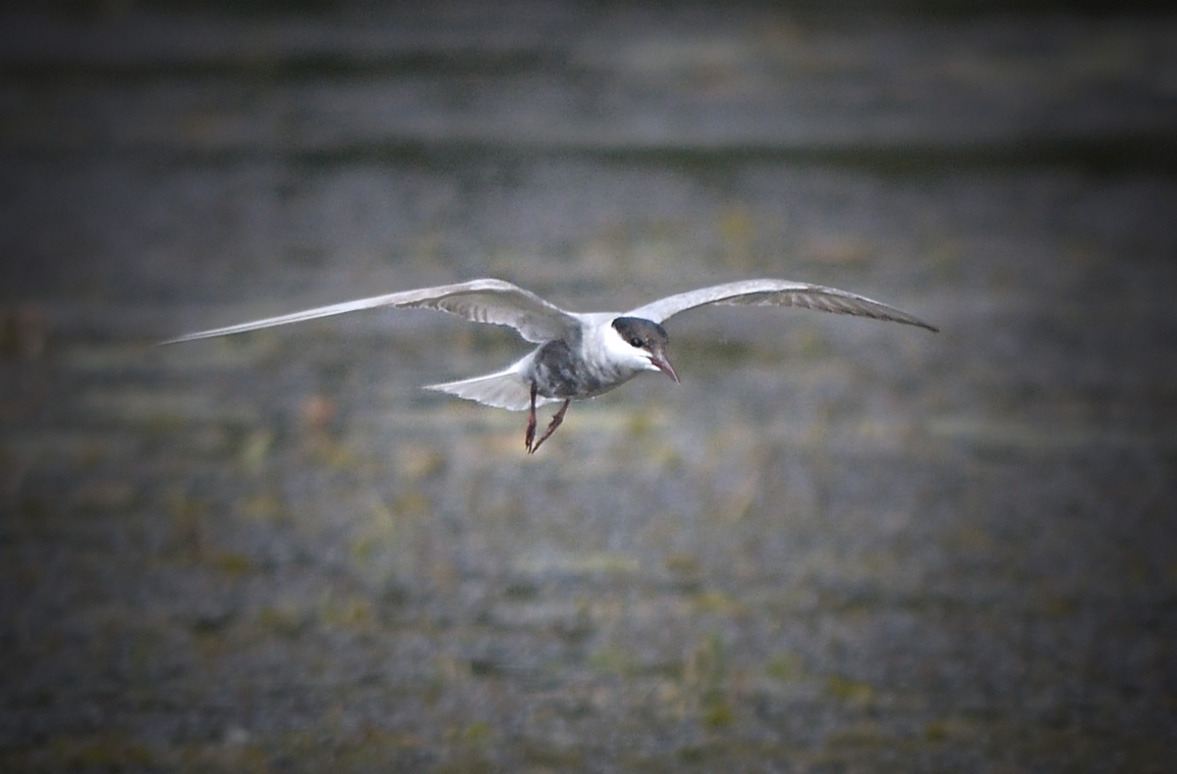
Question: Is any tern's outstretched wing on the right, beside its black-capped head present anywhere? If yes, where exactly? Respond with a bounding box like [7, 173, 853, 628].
[626, 280, 937, 332]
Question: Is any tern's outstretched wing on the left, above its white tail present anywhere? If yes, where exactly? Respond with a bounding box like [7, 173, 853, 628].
[162, 279, 578, 343]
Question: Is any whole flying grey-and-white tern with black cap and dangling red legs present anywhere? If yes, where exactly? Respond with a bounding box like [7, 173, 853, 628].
[161, 279, 937, 454]
